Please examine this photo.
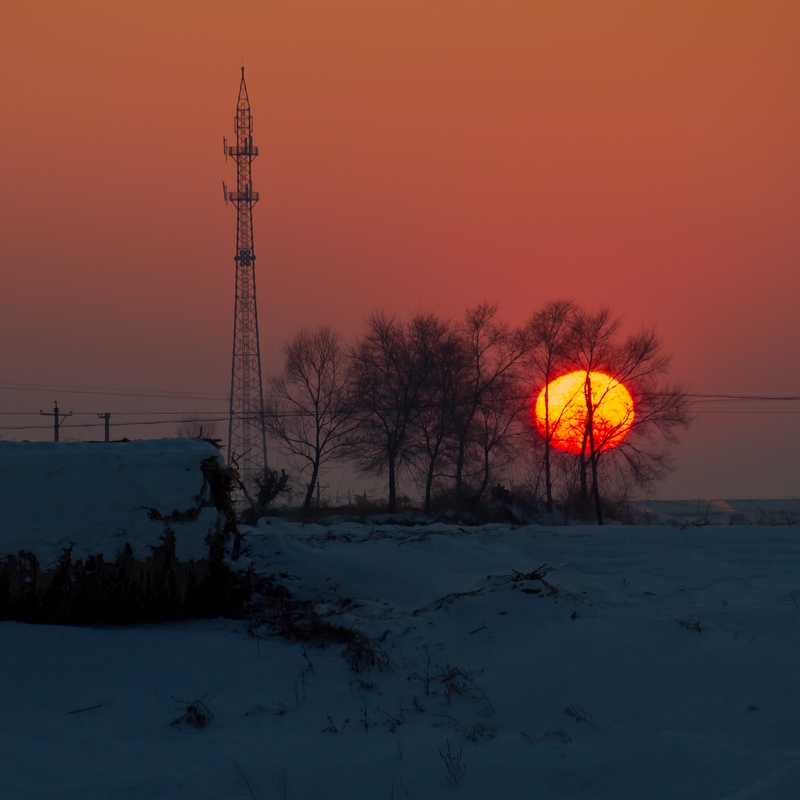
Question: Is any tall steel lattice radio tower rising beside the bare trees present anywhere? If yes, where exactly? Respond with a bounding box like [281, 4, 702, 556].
[222, 67, 267, 488]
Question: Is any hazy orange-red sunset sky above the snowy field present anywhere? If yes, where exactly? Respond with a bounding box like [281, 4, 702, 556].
[0, 0, 800, 498]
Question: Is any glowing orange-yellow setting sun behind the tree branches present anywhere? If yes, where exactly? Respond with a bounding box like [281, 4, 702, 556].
[532, 370, 633, 453]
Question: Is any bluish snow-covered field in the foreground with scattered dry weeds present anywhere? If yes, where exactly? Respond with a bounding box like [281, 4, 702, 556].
[0, 521, 800, 800]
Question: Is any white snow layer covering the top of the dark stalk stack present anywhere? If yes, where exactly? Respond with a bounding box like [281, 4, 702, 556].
[0, 439, 225, 569]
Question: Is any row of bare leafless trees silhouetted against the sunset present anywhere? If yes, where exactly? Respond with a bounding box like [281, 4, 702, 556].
[265, 301, 689, 522]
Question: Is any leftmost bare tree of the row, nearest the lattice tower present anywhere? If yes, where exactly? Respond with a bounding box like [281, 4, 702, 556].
[265, 328, 354, 515]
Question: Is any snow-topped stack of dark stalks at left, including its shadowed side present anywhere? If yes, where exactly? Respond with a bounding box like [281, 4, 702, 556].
[0, 439, 248, 621]
